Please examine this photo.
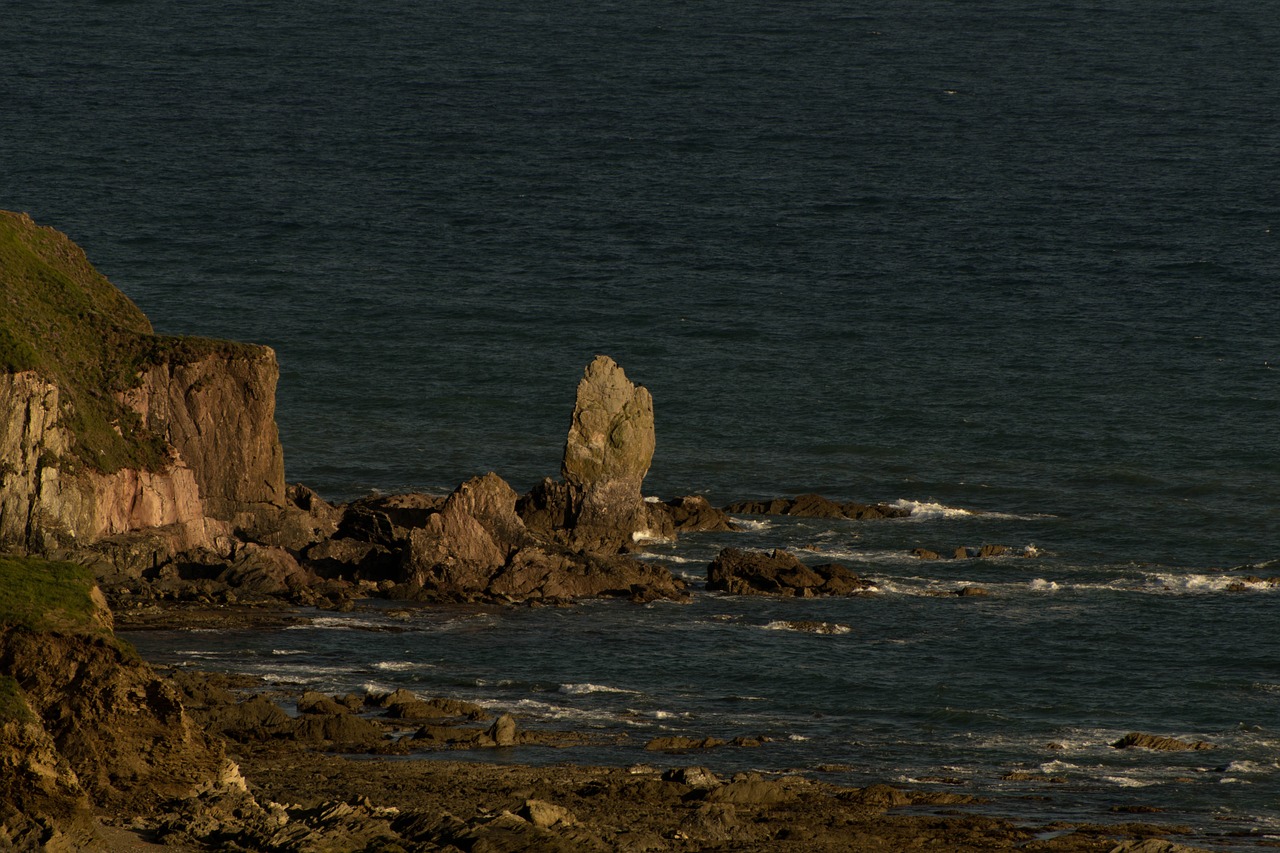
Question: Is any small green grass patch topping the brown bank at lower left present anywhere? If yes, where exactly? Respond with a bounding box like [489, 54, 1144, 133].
[0, 556, 109, 634]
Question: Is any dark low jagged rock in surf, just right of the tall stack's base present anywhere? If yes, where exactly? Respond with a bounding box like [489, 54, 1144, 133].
[707, 548, 874, 598]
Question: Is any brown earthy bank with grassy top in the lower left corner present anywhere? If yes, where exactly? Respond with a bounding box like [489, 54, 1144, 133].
[0, 550, 228, 849]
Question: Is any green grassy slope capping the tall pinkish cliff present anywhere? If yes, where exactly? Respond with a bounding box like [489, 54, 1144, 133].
[0, 211, 261, 471]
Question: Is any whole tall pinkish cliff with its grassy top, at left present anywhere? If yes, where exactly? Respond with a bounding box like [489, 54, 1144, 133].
[0, 211, 285, 553]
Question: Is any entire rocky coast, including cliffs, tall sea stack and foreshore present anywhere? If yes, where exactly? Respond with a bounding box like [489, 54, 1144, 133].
[0, 213, 1280, 853]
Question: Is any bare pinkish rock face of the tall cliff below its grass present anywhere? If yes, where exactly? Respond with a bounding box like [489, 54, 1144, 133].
[0, 347, 285, 551]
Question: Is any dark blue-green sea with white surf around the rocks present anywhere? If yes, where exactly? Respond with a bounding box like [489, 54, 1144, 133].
[0, 0, 1280, 850]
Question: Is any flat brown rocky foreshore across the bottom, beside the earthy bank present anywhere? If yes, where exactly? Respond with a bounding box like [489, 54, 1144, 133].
[110, 645, 1213, 853]
